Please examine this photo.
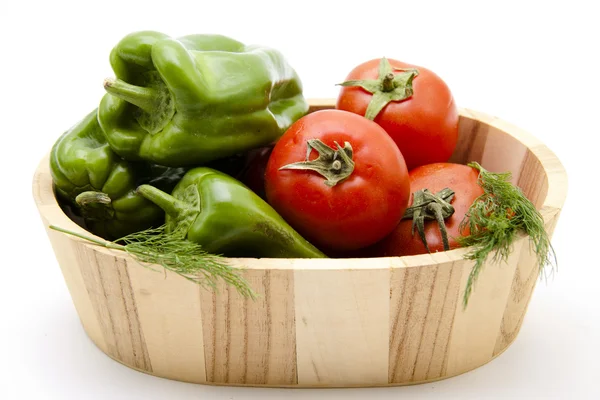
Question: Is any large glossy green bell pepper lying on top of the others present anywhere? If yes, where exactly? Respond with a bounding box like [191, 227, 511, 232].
[98, 31, 308, 166]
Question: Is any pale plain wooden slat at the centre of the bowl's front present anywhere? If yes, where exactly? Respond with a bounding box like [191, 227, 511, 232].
[294, 269, 390, 386]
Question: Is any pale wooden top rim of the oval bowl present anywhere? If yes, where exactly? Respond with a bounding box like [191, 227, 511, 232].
[32, 98, 567, 270]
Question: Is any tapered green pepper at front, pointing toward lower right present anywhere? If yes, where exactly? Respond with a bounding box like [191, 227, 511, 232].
[137, 167, 325, 258]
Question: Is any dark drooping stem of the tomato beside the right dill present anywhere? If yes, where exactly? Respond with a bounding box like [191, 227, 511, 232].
[402, 188, 454, 253]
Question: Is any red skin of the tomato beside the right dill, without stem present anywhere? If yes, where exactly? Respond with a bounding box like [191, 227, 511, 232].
[370, 163, 483, 257]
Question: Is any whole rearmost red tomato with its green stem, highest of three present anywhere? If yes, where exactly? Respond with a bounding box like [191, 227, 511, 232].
[336, 58, 458, 170]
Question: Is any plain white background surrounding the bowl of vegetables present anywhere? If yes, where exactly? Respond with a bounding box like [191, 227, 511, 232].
[0, 0, 600, 400]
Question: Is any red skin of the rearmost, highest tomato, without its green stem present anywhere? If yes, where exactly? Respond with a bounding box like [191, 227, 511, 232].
[336, 59, 458, 171]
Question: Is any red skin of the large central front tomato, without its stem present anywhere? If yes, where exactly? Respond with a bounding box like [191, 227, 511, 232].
[265, 110, 410, 252]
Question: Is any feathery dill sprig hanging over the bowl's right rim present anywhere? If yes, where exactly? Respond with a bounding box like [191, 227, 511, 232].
[458, 162, 556, 308]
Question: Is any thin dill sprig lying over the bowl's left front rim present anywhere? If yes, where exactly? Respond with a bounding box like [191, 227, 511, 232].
[50, 225, 256, 298]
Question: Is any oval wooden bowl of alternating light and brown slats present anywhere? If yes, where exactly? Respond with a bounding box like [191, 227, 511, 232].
[33, 99, 567, 387]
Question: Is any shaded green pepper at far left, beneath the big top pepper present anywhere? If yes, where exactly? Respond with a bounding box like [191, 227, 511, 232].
[50, 110, 185, 240]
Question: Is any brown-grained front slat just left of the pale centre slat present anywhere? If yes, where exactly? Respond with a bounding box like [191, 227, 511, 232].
[201, 270, 297, 384]
